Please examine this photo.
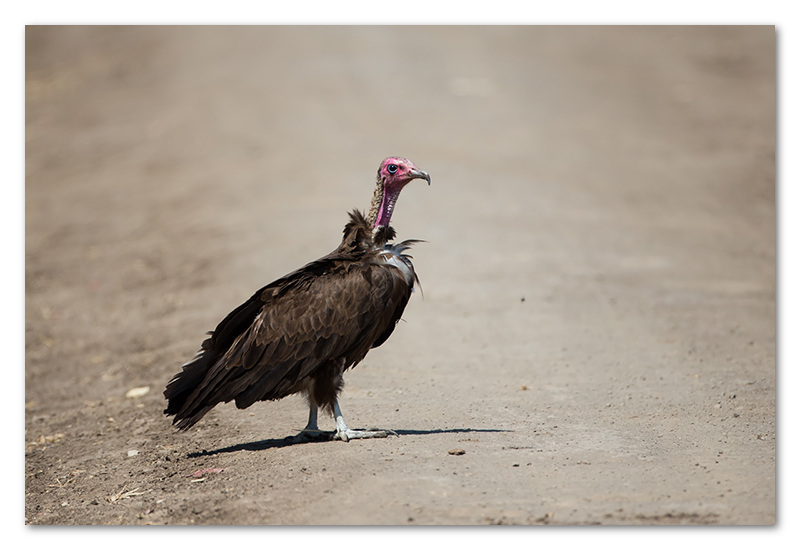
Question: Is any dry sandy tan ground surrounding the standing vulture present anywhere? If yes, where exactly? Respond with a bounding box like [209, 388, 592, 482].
[25, 27, 776, 525]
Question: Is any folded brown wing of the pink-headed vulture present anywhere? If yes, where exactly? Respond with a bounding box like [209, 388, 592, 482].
[165, 254, 411, 429]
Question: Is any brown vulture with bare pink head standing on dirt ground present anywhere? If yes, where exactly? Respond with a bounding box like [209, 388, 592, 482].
[164, 157, 431, 441]
